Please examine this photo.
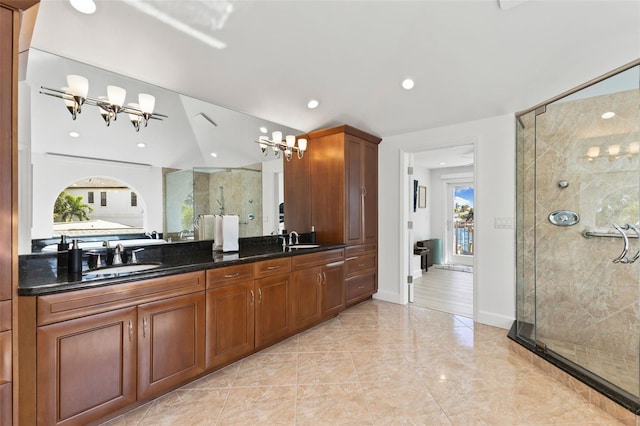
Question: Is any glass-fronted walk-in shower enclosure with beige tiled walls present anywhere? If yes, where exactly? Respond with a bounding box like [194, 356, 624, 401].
[512, 61, 640, 411]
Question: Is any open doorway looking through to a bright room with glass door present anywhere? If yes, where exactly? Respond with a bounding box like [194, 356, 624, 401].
[406, 144, 475, 318]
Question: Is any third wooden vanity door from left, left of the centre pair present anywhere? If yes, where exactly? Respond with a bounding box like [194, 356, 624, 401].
[206, 280, 255, 370]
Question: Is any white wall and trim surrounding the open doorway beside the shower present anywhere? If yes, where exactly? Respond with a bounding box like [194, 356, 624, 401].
[375, 114, 515, 328]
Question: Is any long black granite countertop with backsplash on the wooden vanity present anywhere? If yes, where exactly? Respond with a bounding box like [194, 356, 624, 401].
[18, 237, 345, 296]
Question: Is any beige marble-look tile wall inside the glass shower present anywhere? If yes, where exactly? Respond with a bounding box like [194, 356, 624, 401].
[517, 90, 640, 359]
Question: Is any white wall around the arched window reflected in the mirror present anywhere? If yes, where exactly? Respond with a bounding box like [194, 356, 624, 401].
[30, 152, 163, 243]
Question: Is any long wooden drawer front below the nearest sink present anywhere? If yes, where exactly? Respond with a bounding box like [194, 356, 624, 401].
[37, 271, 205, 325]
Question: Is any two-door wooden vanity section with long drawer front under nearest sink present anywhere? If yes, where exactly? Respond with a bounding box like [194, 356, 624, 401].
[20, 271, 205, 425]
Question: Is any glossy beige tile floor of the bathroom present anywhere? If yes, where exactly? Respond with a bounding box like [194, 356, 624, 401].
[101, 301, 619, 426]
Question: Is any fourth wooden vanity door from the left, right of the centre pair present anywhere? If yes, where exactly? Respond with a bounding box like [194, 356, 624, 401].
[255, 273, 291, 348]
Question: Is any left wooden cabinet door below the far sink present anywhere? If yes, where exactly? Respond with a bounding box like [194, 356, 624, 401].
[291, 266, 324, 329]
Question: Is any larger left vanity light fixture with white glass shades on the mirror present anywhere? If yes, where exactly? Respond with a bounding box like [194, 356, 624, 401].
[40, 74, 167, 132]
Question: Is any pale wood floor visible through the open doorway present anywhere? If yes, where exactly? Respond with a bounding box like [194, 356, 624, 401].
[413, 267, 473, 318]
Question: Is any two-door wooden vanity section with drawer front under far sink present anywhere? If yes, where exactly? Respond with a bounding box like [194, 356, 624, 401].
[291, 249, 345, 330]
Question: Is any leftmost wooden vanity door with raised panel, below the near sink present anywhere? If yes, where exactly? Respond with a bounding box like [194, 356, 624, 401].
[36, 307, 136, 425]
